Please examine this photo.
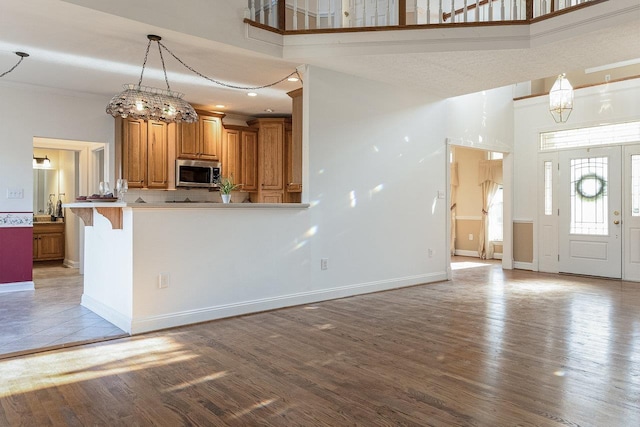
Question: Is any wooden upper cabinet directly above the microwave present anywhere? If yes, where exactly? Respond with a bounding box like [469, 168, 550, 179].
[176, 111, 224, 161]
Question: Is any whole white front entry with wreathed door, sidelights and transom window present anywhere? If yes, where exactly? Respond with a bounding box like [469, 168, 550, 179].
[538, 122, 640, 281]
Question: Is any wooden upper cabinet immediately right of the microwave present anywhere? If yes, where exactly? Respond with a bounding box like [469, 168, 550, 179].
[221, 125, 258, 191]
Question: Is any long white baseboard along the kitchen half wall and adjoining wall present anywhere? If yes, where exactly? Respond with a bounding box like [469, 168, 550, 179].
[131, 272, 447, 334]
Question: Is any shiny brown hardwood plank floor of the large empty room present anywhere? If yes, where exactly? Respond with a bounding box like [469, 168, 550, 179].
[0, 264, 640, 426]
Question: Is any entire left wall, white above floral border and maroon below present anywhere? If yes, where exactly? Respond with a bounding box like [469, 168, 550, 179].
[0, 83, 114, 291]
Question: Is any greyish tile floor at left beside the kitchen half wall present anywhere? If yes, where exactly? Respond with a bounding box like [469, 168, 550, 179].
[0, 263, 128, 359]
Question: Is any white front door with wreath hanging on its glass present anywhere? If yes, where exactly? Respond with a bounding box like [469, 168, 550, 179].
[558, 147, 622, 278]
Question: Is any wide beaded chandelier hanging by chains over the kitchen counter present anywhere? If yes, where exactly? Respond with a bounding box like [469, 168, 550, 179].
[106, 34, 198, 123]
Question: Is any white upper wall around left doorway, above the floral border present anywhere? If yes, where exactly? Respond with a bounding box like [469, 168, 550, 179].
[0, 83, 114, 216]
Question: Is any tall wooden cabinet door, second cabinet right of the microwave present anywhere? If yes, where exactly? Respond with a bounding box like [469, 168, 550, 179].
[258, 123, 284, 190]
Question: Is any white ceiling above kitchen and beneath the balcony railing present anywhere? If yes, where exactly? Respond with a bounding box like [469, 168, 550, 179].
[0, 0, 640, 116]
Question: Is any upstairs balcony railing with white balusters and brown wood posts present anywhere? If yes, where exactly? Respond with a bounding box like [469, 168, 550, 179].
[246, 0, 608, 34]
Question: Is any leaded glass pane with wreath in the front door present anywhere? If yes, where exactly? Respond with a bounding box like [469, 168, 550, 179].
[569, 157, 609, 236]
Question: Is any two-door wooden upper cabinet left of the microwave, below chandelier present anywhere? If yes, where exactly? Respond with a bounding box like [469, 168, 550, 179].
[116, 118, 169, 189]
